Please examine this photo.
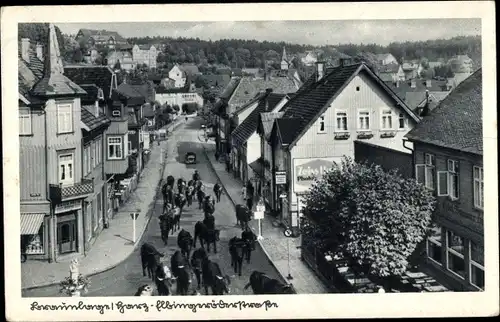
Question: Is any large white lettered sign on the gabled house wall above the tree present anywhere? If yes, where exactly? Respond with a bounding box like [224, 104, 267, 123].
[293, 156, 342, 193]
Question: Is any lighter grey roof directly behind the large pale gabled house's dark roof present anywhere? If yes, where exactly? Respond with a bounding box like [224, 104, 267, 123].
[228, 77, 297, 110]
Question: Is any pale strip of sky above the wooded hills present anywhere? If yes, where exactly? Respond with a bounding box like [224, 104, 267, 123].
[56, 19, 481, 46]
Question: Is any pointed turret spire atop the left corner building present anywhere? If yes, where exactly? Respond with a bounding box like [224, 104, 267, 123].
[32, 24, 87, 96]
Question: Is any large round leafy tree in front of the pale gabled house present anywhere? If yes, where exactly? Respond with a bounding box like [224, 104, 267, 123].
[303, 158, 435, 279]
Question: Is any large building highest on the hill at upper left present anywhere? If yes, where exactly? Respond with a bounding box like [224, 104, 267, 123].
[75, 29, 128, 49]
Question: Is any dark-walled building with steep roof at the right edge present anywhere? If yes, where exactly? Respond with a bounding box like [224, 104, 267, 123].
[406, 69, 484, 291]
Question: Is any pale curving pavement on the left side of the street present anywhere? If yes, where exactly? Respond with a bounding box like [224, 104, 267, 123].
[21, 122, 184, 289]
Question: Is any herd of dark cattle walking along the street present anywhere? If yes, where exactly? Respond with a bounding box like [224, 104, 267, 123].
[135, 171, 293, 296]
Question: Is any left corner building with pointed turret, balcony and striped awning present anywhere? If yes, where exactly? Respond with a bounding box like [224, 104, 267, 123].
[18, 24, 114, 261]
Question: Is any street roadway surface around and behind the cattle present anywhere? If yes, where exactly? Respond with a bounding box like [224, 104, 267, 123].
[22, 118, 284, 297]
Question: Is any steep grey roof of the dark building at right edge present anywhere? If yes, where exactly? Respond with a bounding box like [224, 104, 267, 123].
[406, 69, 483, 155]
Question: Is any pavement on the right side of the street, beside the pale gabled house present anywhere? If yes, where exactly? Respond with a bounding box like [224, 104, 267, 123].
[203, 143, 329, 294]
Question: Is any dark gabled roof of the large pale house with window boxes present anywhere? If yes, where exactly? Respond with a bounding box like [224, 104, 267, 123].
[282, 63, 419, 148]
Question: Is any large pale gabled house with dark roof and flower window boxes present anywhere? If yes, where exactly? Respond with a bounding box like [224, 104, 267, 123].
[269, 61, 420, 230]
